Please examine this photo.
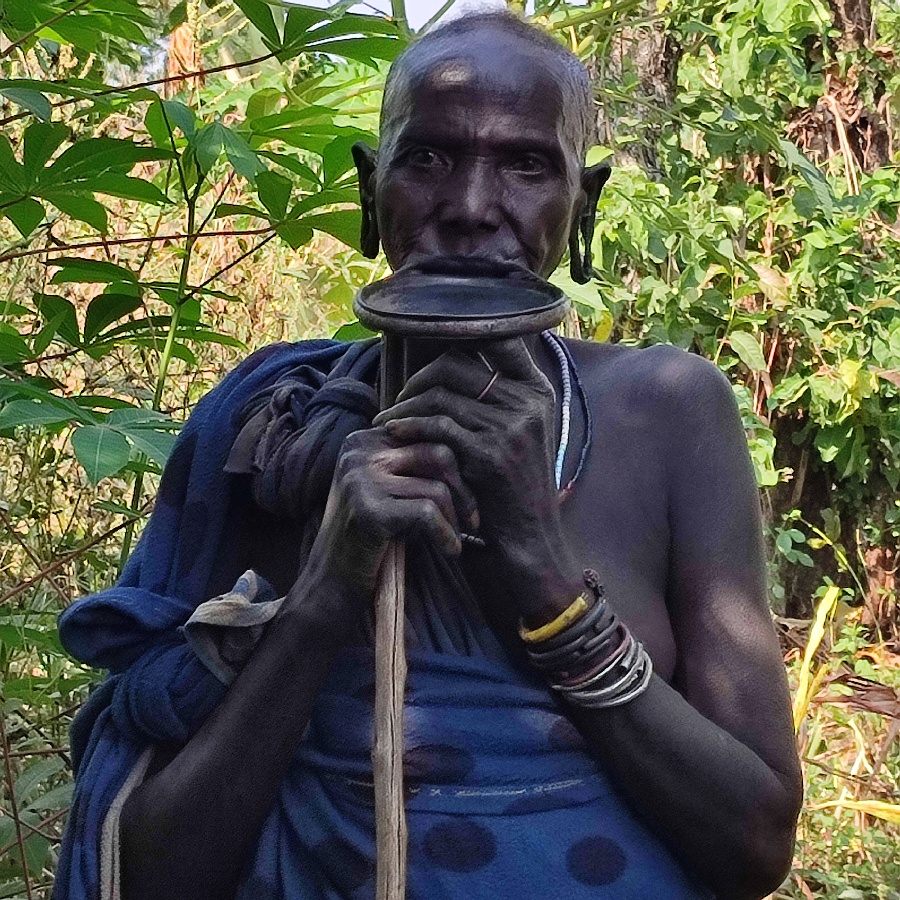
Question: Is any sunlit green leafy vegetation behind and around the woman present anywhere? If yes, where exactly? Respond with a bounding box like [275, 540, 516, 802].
[0, 0, 900, 900]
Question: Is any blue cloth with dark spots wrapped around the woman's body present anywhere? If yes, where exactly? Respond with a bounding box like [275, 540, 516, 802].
[54, 341, 710, 900]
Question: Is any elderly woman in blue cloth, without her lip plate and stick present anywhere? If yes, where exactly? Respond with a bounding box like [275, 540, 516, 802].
[57, 14, 800, 900]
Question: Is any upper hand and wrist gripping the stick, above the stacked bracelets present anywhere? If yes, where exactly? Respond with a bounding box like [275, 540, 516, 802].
[374, 338, 581, 620]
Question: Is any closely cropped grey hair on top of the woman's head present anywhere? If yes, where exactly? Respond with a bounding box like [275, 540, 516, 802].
[381, 12, 594, 160]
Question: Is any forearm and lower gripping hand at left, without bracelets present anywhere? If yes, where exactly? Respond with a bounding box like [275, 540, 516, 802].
[119, 428, 476, 900]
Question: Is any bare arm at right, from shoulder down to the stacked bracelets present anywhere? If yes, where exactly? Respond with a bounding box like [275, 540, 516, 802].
[571, 354, 802, 900]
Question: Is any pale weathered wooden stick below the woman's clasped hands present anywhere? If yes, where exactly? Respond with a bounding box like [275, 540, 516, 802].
[372, 541, 407, 900]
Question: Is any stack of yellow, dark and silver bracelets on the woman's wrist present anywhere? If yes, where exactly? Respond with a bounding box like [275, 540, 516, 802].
[519, 569, 653, 709]
